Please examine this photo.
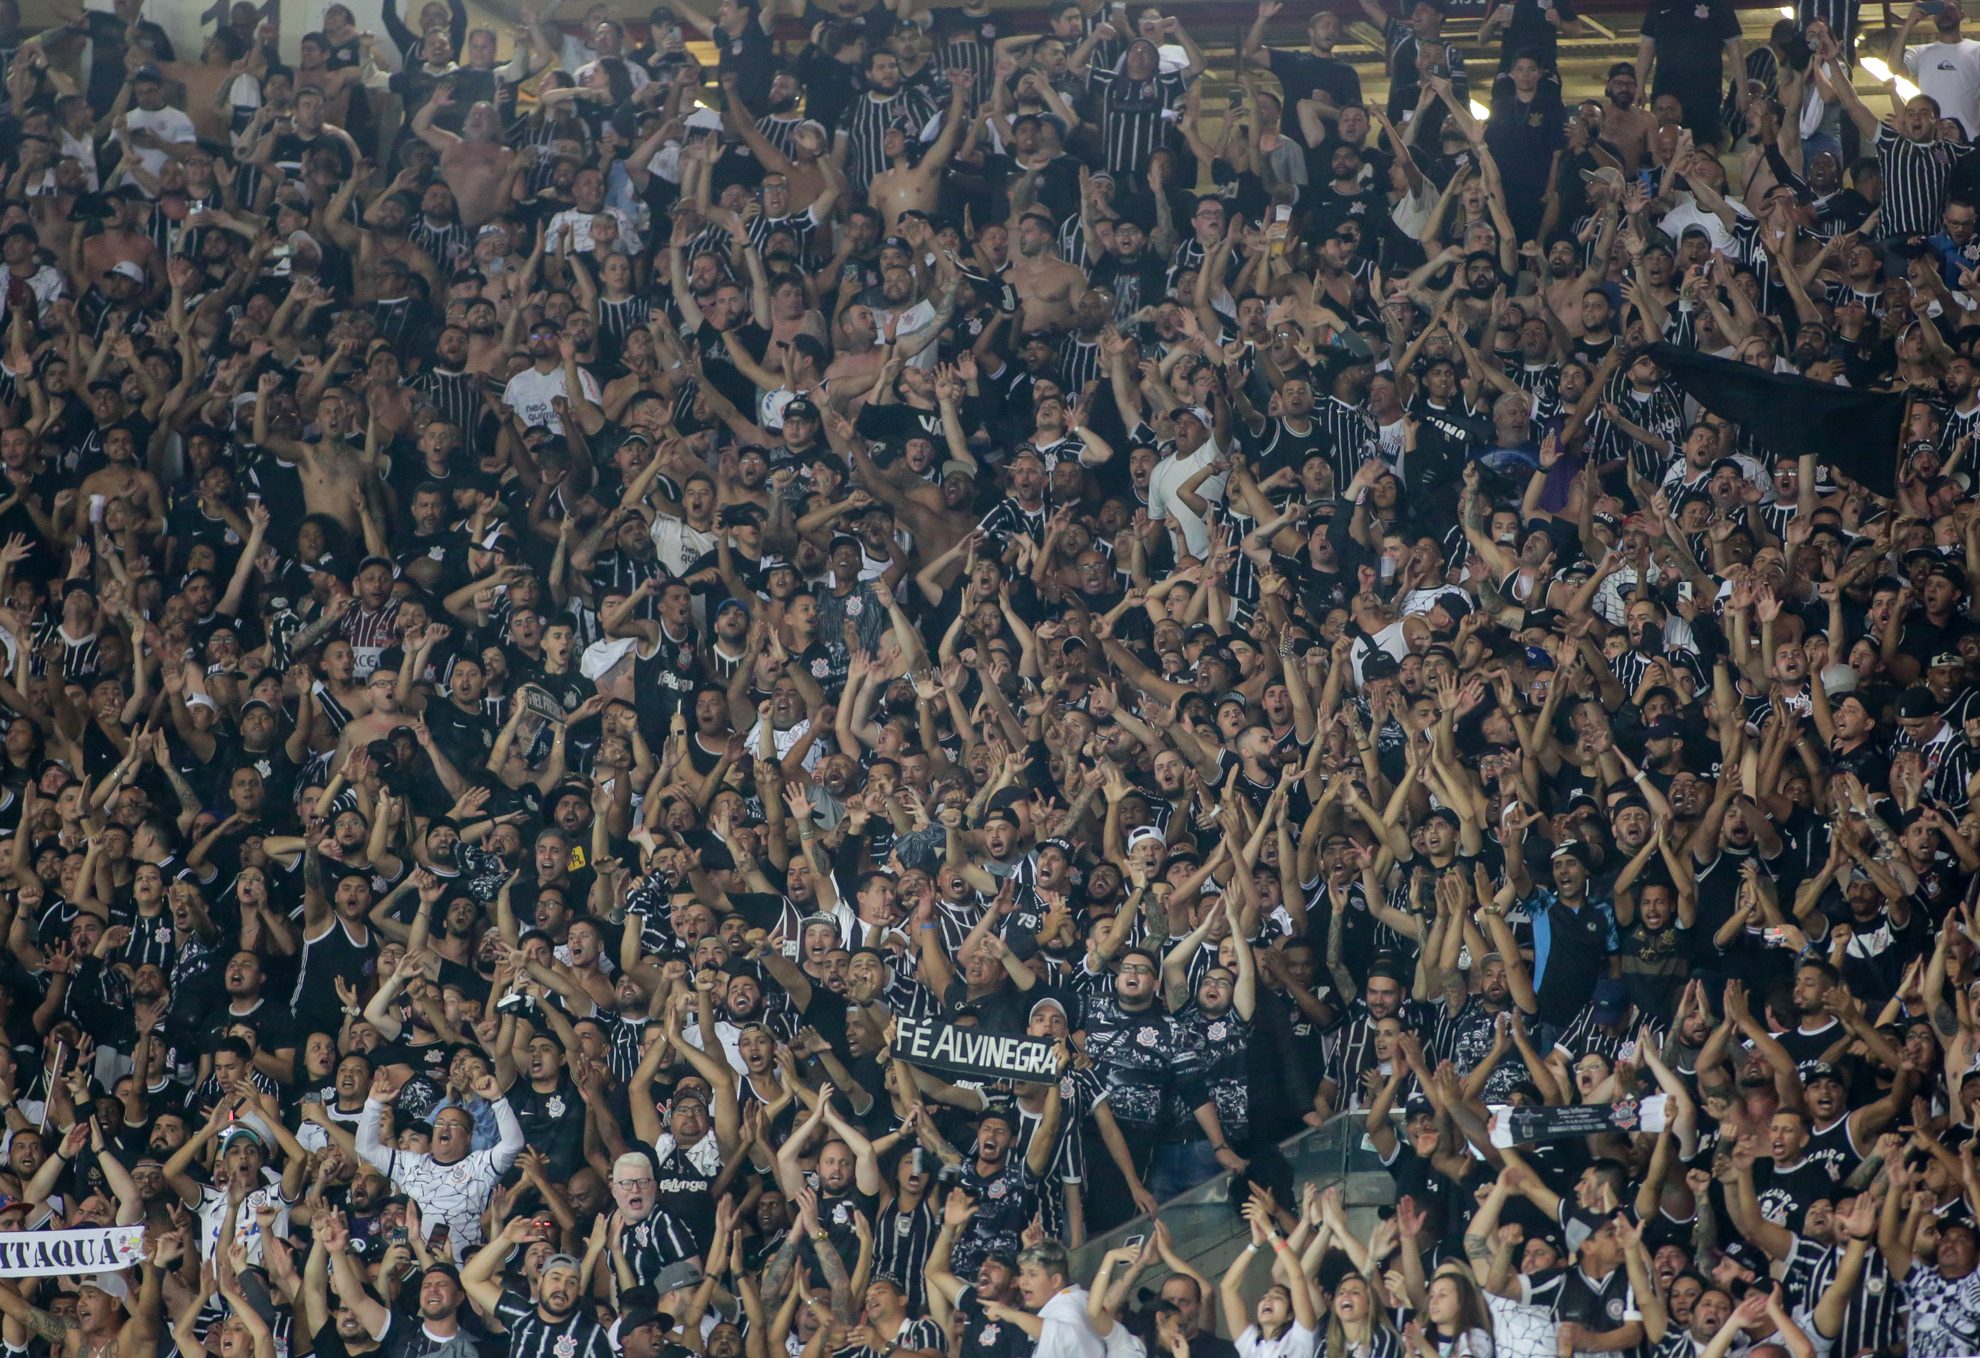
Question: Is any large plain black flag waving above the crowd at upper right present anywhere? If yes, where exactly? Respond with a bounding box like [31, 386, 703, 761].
[1649, 344, 1907, 497]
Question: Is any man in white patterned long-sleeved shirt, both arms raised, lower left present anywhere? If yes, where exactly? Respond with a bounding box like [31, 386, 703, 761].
[356, 1071, 525, 1266]
